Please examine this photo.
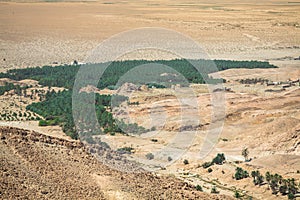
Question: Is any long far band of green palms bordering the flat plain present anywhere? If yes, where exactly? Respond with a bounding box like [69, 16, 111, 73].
[0, 59, 276, 89]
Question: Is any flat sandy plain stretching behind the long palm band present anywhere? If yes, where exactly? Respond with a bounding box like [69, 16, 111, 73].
[0, 0, 300, 71]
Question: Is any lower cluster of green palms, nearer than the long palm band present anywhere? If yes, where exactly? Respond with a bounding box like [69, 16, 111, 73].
[26, 90, 147, 139]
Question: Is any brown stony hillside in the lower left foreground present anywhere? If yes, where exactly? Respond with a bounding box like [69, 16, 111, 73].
[0, 127, 231, 199]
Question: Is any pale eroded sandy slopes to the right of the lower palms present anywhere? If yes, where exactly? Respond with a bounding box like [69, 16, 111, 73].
[101, 83, 300, 200]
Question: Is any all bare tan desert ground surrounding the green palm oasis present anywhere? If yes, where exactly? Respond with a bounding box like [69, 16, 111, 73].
[0, 0, 300, 200]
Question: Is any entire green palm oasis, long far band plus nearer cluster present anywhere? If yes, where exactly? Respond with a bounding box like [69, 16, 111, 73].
[0, 59, 275, 139]
